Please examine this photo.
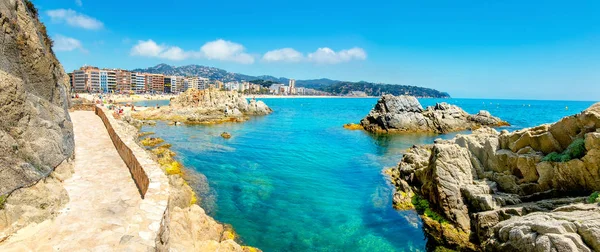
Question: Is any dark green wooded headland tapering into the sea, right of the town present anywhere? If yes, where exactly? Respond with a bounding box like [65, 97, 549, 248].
[319, 81, 450, 98]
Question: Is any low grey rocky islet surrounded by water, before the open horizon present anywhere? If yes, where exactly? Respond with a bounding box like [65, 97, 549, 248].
[360, 95, 509, 134]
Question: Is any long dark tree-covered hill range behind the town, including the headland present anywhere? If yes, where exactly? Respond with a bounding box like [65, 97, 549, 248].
[131, 64, 450, 98]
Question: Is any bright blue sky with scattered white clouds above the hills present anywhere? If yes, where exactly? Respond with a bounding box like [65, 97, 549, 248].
[33, 0, 600, 100]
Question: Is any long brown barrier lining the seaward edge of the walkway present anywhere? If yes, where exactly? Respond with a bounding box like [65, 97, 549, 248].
[95, 107, 150, 198]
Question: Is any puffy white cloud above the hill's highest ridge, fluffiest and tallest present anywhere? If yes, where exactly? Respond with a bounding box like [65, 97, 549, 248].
[200, 39, 254, 64]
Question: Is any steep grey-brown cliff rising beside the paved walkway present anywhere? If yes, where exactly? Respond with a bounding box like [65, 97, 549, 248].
[0, 0, 74, 238]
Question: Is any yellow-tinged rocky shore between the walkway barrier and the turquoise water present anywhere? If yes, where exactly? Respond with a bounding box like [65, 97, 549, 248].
[115, 113, 260, 252]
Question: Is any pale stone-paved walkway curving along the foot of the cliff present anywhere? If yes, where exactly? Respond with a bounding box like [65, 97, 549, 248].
[0, 111, 169, 251]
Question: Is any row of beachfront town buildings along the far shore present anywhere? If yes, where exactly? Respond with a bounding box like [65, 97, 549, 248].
[68, 66, 328, 96]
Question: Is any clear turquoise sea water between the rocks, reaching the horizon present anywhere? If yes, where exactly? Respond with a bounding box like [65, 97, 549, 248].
[138, 98, 593, 252]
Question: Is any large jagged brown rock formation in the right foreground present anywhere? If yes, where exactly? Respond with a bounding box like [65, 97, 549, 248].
[387, 103, 600, 251]
